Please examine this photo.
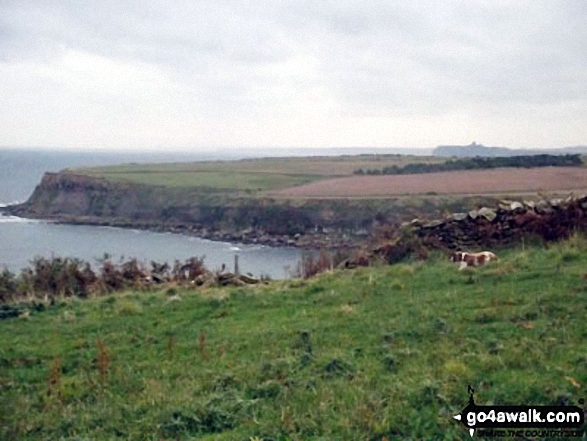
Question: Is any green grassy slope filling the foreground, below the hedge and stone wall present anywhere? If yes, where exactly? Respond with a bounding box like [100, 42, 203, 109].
[0, 238, 587, 440]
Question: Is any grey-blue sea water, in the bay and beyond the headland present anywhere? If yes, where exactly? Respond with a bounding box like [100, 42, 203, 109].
[0, 150, 300, 279]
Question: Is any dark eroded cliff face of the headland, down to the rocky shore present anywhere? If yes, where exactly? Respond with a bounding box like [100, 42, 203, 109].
[6, 171, 484, 248]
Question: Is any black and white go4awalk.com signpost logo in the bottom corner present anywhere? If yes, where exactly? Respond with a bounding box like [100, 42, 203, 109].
[453, 386, 585, 438]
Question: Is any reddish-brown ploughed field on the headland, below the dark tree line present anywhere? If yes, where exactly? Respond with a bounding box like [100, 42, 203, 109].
[271, 167, 587, 198]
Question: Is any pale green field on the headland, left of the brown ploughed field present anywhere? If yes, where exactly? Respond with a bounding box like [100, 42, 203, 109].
[74, 155, 446, 191]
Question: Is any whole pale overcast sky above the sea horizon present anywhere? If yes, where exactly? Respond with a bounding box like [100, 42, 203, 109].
[0, 0, 587, 149]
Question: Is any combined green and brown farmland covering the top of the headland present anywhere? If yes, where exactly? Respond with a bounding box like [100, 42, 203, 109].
[73, 155, 587, 198]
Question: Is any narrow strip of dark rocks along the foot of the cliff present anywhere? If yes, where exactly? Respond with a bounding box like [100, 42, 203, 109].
[0, 205, 365, 250]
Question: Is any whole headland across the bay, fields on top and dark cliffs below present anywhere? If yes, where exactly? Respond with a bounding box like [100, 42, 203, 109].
[14, 155, 587, 244]
